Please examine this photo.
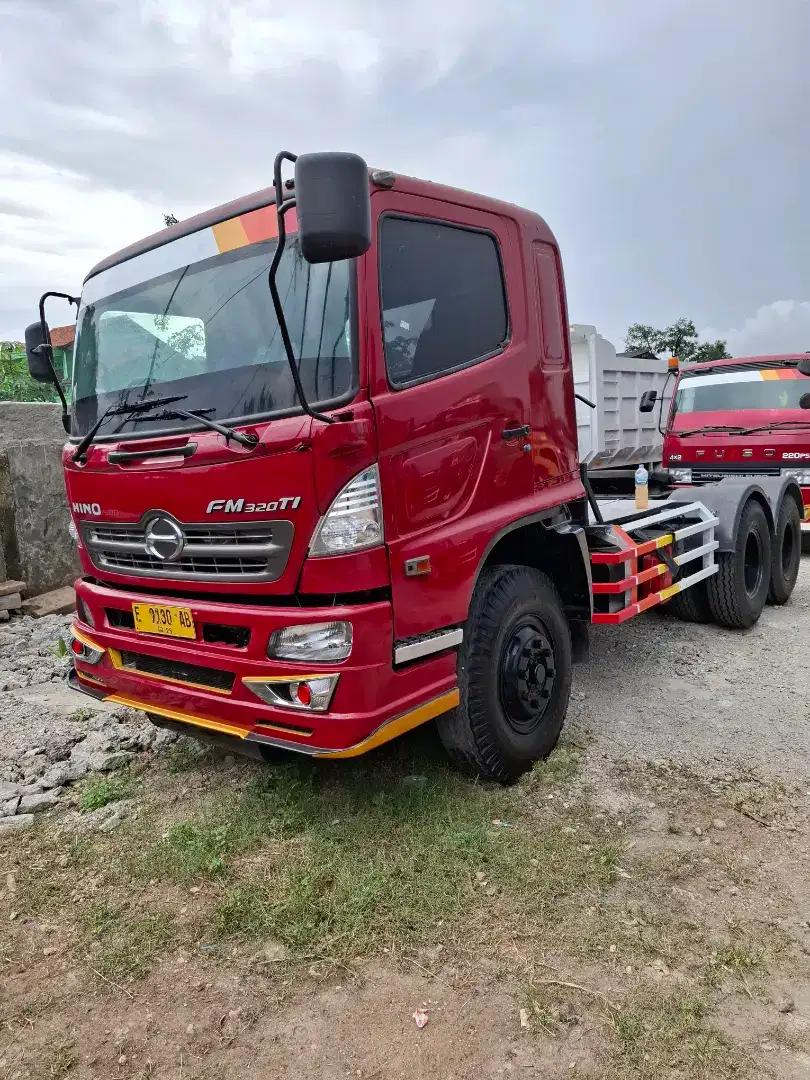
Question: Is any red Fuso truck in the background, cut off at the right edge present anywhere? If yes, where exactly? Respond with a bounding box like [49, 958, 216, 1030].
[663, 354, 810, 545]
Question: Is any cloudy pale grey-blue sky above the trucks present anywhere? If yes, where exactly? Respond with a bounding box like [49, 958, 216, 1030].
[0, 0, 810, 355]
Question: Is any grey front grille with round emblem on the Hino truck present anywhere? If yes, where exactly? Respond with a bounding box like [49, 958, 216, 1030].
[81, 511, 295, 582]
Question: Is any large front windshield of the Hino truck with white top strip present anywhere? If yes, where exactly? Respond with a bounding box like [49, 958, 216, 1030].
[72, 230, 355, 437]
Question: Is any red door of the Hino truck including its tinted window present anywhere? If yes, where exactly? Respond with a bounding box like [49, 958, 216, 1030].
[366, 191, 532, 640]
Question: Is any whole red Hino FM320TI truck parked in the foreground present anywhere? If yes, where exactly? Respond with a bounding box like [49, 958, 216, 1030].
[26, 151, 800, 782]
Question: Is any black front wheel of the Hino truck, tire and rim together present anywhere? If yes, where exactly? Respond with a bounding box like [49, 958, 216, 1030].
[437, 566, 571, 783]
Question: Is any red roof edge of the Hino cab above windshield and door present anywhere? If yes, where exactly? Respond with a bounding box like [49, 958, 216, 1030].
[84, 170, 556, 282]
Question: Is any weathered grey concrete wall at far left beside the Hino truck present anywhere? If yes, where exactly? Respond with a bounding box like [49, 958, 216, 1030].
[0, 402, 79, 596]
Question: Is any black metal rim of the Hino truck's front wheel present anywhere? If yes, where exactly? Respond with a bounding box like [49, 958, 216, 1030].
[498, 616, 557, 735]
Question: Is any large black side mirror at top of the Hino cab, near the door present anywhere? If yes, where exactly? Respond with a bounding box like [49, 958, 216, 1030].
[295, 153, 372, 262]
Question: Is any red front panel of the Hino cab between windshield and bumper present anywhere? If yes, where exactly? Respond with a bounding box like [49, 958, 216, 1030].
[64, 403, 376, 595]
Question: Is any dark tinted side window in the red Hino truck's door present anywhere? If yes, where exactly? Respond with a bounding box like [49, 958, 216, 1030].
[380, 217, 509, 387]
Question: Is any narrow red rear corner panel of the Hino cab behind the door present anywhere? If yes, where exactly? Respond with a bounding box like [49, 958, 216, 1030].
[529, 241, 588, 490]
